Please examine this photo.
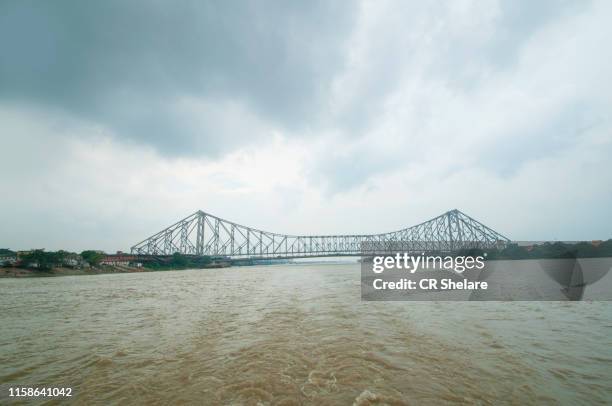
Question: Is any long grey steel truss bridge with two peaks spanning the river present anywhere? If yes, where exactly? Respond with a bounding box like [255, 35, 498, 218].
[131, 210, 510, 259]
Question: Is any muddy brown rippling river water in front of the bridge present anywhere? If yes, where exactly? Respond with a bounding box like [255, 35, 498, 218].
[0, 264, 612, 405]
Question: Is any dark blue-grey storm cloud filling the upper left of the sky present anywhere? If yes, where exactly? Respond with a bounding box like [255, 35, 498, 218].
[0, 1, 354, 154]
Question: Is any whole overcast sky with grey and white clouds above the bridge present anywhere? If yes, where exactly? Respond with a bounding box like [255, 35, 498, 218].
[0, 0, 612, 252]
